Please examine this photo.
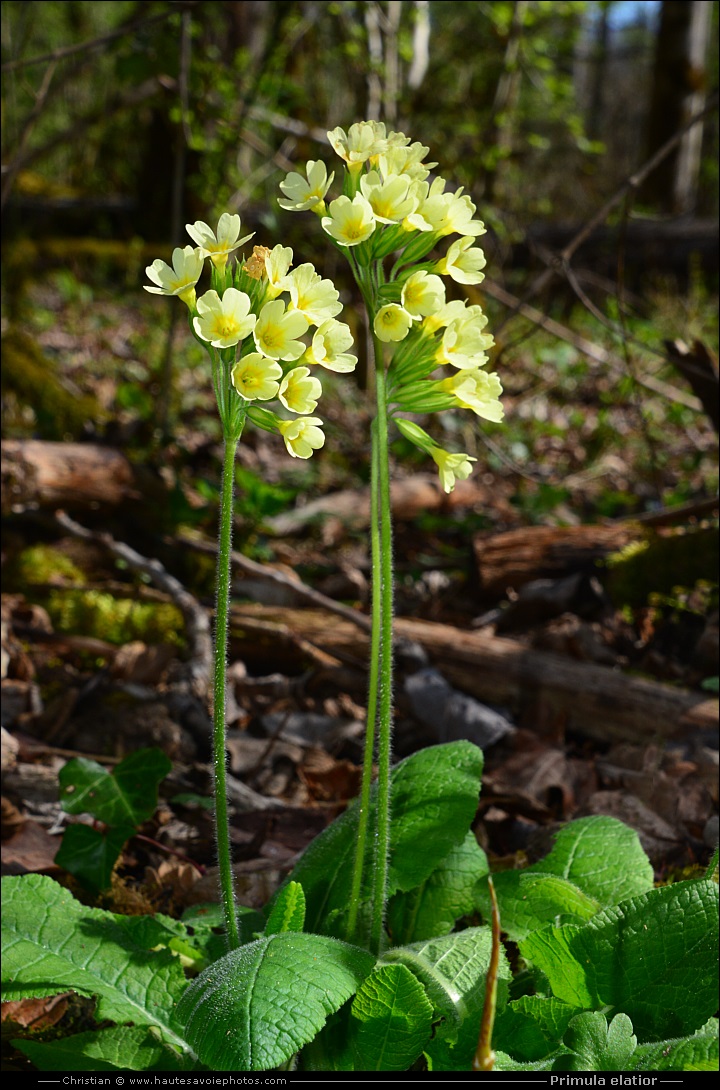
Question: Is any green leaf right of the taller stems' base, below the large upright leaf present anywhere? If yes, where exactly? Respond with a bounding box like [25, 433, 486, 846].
[388, 831, 487, 945]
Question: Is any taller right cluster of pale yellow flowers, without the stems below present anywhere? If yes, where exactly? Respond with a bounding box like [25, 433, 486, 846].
[275, 121, 503, 492]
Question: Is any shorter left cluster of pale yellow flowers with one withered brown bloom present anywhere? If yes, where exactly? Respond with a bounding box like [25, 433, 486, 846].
[146, 212, 357, 458]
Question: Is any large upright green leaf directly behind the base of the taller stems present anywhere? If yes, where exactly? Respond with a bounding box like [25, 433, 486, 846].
[283, 741, 483, 934]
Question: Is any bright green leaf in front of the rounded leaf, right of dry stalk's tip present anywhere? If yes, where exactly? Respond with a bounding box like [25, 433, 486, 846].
[477, 870, 602, 942]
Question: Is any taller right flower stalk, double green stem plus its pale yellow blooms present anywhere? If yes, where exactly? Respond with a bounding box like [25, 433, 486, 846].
[280, 121, 503, 954]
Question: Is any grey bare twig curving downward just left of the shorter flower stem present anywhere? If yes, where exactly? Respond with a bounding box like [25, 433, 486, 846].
[54, 511, 212, 697]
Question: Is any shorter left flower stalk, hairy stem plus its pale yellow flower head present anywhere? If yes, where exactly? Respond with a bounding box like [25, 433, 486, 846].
[146, 213, 357, 950]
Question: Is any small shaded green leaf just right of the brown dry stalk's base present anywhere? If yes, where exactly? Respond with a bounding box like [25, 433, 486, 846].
[492, 995, 581, 1062]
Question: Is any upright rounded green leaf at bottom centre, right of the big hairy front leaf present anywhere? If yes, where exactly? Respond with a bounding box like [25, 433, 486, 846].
[350, 965, 432, 1071]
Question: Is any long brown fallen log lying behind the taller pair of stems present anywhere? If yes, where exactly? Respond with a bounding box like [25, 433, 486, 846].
[231, 605, 719, 743]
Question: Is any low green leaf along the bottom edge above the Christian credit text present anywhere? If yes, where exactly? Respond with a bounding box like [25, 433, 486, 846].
[13, 1026, 195, 1071]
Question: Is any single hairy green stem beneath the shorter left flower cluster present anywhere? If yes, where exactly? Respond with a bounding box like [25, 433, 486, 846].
[212, 426, 242, 950]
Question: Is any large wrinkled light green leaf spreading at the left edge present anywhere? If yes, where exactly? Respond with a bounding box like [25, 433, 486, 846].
[2, 874, 190, 1052]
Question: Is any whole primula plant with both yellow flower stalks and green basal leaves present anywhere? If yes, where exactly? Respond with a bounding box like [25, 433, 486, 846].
[3, 122, 718, 1072]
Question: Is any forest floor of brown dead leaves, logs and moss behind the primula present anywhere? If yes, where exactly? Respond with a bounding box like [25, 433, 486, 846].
[2, 263, 718, 1046]
